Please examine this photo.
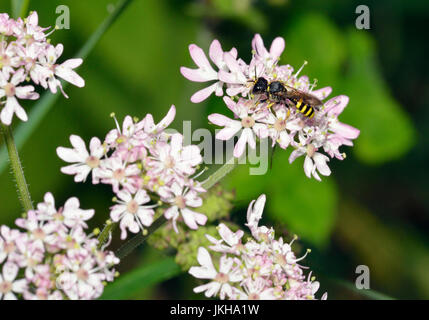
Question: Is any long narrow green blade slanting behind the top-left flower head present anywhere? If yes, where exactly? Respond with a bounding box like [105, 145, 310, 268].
[0, 0, 132, 173]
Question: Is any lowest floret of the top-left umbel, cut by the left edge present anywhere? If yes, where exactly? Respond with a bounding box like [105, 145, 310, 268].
[0, 69, 39, 125]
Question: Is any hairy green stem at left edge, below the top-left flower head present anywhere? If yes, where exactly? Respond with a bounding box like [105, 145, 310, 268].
[2, 124, 33, 212]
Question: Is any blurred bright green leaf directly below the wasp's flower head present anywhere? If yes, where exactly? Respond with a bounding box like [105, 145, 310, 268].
[222, 150, 337, 246]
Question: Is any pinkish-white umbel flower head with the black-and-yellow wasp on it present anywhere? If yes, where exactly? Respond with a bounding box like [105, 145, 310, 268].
[180, 34, 360, 180]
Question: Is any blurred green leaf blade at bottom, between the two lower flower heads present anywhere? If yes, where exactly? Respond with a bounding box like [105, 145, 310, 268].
[100, 258, 181, 300]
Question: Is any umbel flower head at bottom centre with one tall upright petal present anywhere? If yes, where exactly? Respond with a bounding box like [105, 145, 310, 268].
[189, 195, 327, 300]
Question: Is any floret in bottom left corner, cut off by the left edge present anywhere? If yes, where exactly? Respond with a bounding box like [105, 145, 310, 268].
[0, 262, 27, 300]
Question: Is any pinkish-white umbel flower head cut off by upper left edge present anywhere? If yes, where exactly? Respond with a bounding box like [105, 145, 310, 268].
[0, 12, 85, 125]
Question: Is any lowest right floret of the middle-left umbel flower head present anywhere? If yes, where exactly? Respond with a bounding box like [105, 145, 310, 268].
[159, 182, 207, 233]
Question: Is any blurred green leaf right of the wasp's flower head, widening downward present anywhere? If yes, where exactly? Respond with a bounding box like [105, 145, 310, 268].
[341, 30, 416, 164]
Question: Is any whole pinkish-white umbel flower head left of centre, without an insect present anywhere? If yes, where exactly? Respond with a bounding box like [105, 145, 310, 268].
[57, 106, 207, 239]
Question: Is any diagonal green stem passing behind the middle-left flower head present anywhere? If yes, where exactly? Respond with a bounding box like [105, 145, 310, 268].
[108, 158, 237, 259]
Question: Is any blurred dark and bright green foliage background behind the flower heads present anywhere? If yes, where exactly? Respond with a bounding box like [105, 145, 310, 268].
[0, 0, 429, 299]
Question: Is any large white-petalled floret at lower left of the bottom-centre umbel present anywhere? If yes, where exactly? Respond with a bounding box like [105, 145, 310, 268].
[189, 247, 243, 300]
